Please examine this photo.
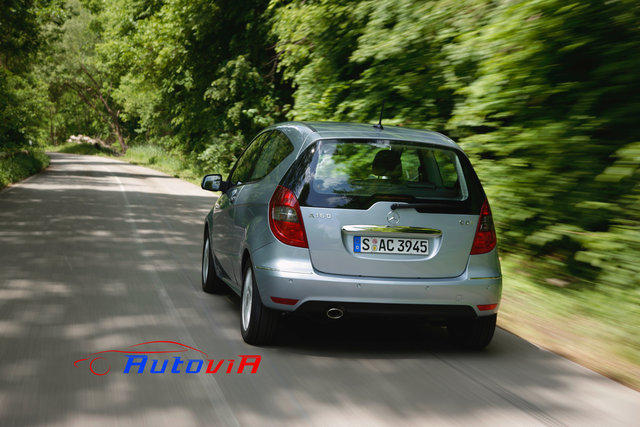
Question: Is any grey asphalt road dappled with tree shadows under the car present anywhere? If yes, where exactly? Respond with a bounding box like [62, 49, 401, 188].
[0, 154, 640, 426]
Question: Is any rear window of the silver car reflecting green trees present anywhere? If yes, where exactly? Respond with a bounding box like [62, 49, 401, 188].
[283, 140, 481, 213]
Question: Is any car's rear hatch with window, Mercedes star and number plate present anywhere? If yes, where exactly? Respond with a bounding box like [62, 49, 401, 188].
[284, 139, 484, 278]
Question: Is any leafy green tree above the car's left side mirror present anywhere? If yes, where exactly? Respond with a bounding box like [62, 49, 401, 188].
[98, 0, 278, 168]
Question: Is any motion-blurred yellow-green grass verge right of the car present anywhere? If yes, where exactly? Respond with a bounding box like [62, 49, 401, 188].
[498, 254, 640, 390]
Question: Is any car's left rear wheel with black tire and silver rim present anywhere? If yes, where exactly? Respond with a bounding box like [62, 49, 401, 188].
[240, 261, 280, 345]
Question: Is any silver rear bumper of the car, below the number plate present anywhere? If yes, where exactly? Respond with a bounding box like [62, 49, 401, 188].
[255, 264, 502, 317]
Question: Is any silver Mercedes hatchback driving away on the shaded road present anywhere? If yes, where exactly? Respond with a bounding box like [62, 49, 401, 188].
[202, 122, 502, 349]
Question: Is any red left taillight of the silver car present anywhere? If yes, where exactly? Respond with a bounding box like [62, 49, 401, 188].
[269, 185, 309, 248]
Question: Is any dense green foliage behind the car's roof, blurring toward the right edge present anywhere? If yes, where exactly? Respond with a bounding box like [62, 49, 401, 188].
[272, 0, 640, 298]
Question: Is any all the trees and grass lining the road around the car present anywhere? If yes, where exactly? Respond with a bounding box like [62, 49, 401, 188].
[0, 0, 640, 387]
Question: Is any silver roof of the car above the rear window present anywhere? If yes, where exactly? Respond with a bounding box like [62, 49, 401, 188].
[269, 122, 460, 149]
